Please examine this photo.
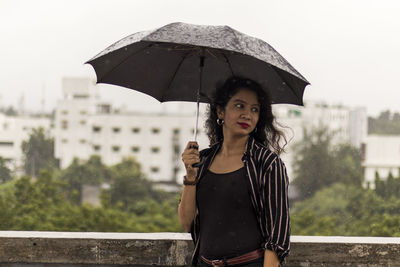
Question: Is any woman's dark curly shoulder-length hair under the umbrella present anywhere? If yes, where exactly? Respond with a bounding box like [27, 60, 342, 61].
[205, 76, 287, 154]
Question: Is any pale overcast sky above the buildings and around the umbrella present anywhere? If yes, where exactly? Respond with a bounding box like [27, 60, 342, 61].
[0, 0, 400, 115]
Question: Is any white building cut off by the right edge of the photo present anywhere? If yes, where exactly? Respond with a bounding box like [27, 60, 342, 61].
[363, 135, 400, 188]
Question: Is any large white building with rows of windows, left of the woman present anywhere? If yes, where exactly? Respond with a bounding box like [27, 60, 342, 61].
[55, 78, 209, 182]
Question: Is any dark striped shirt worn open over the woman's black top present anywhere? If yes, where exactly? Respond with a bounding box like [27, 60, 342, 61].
[190, 136, 290, 264]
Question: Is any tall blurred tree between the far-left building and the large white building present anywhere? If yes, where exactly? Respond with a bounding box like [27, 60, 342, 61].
[21, 127, 58, 177]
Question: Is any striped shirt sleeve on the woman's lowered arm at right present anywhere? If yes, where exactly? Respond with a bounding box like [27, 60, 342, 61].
[265, 157, 290, 262]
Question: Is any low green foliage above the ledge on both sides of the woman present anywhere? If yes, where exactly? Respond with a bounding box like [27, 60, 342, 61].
[0, 151, 400, 236]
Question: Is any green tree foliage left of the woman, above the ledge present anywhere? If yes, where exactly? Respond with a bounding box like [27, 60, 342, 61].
[0, 157, 182, 232]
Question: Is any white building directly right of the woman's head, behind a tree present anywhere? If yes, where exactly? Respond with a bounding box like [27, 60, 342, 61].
[273, 102, 368, 179]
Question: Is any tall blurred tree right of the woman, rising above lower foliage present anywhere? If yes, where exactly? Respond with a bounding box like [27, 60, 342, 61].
[293, 126, 363, 199]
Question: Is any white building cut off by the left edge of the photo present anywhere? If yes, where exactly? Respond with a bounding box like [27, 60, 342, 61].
[0, 113, 51, 174]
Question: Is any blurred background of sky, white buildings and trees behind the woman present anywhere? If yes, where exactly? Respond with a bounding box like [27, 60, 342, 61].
[0, 0, 400, 236]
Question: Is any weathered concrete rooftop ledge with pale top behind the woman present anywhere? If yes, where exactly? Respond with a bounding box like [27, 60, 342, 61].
[0, 231, 400, 267]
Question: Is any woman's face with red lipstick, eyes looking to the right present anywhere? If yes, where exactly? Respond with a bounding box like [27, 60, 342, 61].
[217, 88, 260, 136]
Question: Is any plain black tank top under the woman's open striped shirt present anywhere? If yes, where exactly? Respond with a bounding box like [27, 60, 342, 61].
[196, 167, 262, 259]
